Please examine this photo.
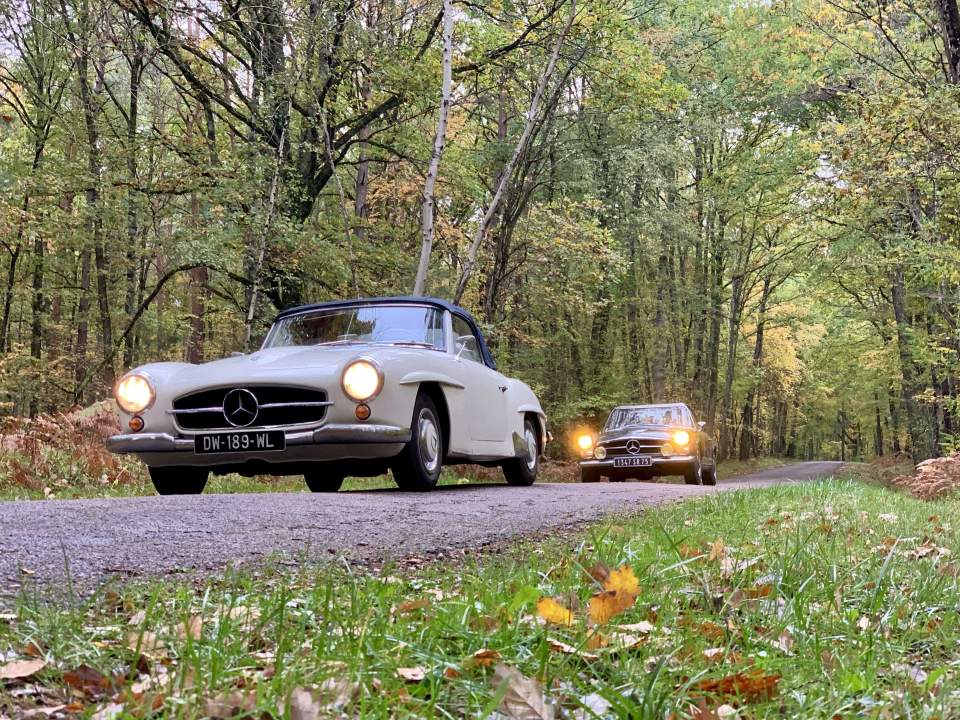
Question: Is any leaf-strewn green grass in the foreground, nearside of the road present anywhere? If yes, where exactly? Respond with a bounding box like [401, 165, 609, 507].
[0, 481, 960, 720]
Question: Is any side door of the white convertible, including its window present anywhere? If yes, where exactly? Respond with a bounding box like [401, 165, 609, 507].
[453, 315, 507, 442]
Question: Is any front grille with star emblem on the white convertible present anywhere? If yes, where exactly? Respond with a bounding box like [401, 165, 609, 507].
[170, 385, 333, 430]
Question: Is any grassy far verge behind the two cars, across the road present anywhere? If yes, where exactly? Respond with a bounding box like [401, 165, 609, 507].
[0, 456, 794, 500]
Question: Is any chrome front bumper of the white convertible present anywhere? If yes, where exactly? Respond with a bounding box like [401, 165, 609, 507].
[106, 423, 410, 453]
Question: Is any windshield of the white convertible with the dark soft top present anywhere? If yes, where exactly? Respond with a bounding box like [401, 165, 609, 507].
[263, 305, 447, 350]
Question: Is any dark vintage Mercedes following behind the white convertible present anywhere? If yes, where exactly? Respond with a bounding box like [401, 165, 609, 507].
[576, 403, 717, 485]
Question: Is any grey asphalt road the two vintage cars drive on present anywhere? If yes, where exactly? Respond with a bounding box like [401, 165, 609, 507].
[0, 462, 840, 595]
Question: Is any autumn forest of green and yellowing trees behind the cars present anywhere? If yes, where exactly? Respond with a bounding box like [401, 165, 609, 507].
[0, 0, 960, 460]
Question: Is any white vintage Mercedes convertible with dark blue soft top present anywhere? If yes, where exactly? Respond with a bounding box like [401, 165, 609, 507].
[107, 297, 548, 495]
